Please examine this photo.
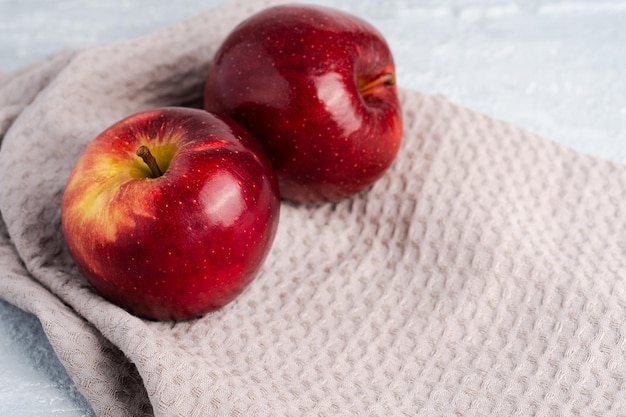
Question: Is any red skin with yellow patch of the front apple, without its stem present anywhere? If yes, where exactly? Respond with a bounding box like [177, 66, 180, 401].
[61, 107, 280, 320]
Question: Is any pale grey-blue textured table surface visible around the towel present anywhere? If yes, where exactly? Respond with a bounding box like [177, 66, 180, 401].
[0, 0, 626, 417]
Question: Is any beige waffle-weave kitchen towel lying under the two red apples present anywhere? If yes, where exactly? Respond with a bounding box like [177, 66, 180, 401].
[0, 0, 626, 417]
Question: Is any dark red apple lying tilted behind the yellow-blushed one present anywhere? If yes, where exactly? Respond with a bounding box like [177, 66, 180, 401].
[204, 5, 402, 204]
